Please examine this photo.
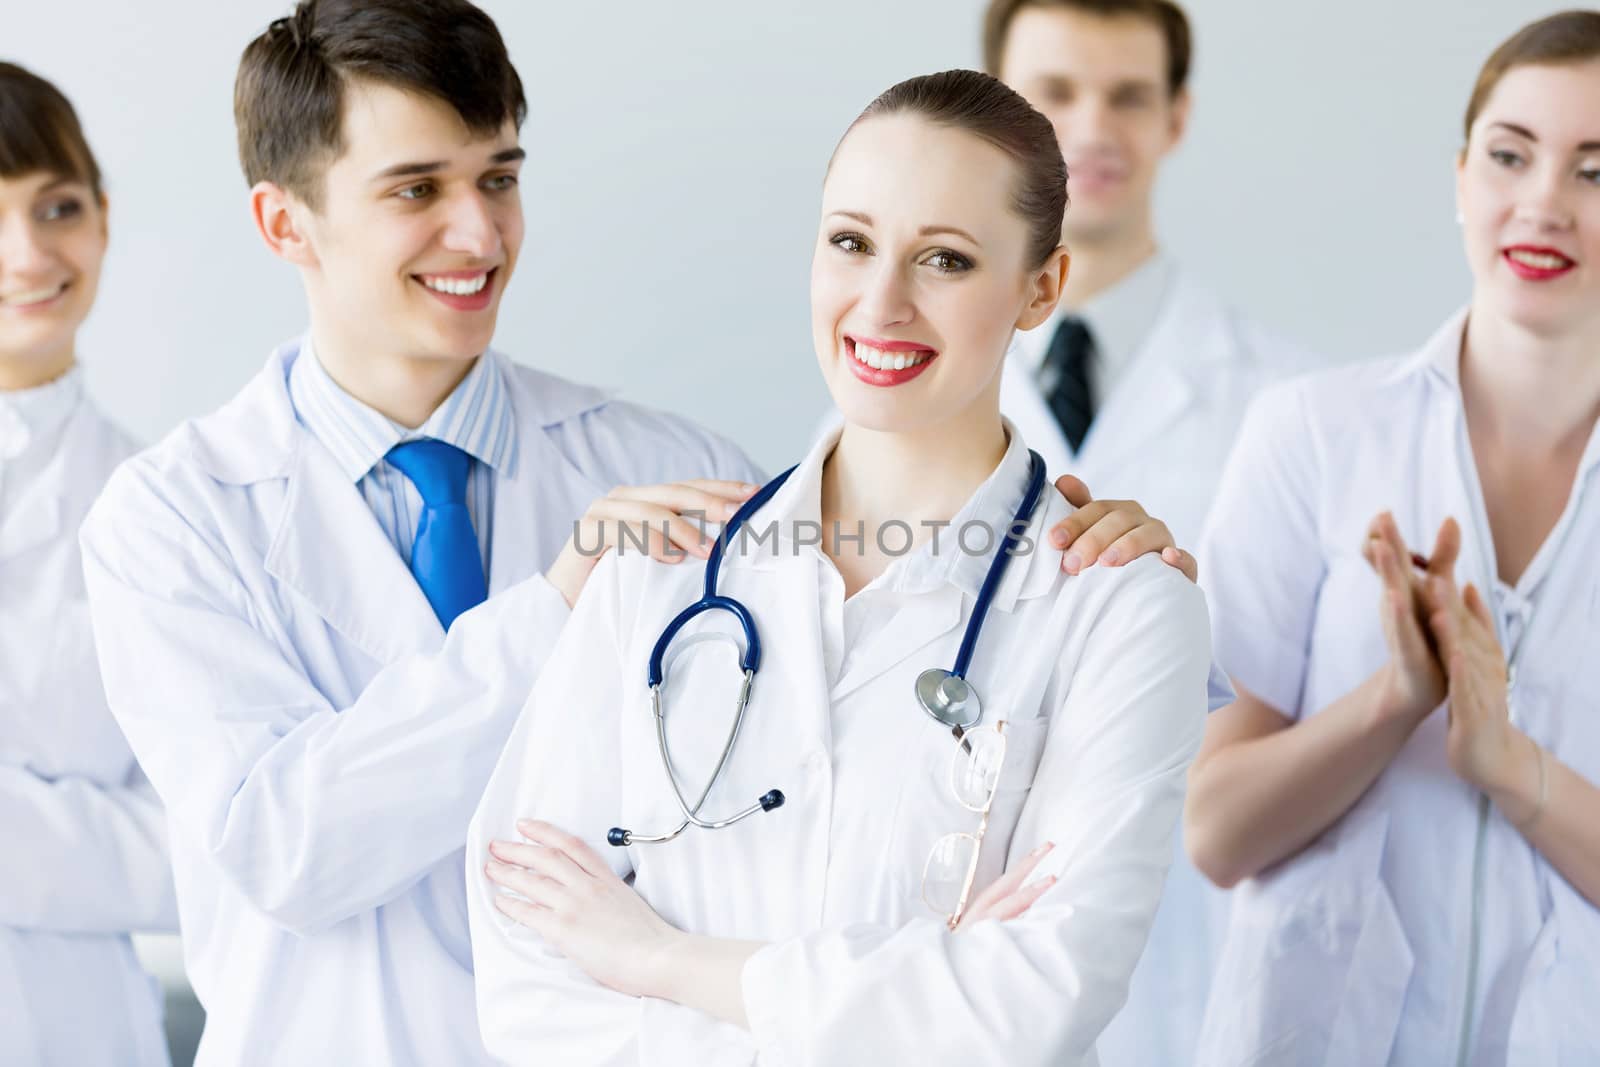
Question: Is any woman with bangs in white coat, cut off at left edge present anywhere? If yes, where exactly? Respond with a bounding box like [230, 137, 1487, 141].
[0, 62, 178, 1067]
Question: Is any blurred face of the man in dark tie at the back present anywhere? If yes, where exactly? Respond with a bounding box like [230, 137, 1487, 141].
[1000, 6, 1189, 246]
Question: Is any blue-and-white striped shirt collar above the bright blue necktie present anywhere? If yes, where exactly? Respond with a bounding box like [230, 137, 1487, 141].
[290, 334, 517, 482]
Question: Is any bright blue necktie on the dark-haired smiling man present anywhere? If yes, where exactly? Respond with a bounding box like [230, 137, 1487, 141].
[384, 437, 488, 630]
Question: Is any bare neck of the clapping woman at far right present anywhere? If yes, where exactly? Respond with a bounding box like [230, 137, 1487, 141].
[1461, 304, 1600, 451]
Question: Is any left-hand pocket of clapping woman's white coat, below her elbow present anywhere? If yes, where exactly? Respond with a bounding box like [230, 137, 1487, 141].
[1195, 813, 1414, 1067]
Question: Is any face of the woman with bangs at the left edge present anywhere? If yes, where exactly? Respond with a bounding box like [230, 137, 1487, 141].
[0, 171, 106, 389]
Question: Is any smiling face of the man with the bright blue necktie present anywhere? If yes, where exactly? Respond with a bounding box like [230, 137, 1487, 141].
[273, 82, 523, 371]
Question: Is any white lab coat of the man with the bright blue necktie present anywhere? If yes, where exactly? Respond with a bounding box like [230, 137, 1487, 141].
[83, 344, 754, 1067]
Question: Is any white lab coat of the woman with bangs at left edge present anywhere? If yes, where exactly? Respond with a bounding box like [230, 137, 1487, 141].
[0, 379, 178, 1067]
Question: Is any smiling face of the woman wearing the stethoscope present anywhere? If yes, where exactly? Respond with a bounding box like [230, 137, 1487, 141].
[811, 114, 1066, 432]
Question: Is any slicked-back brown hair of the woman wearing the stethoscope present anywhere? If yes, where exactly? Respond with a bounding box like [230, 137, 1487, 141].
[835, 70, 1067, 267]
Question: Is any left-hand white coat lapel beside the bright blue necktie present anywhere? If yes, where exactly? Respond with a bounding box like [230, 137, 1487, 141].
[266, 434, 443, 662]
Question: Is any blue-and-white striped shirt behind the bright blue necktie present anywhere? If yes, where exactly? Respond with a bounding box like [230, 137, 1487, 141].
[290, 334, 517, 577]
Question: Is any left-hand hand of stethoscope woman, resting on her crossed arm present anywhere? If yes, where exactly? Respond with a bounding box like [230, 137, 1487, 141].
[483, 819, 683, 997]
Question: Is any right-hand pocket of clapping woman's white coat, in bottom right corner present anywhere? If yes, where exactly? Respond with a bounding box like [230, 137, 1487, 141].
[1506, 891, 1600, 1067]
